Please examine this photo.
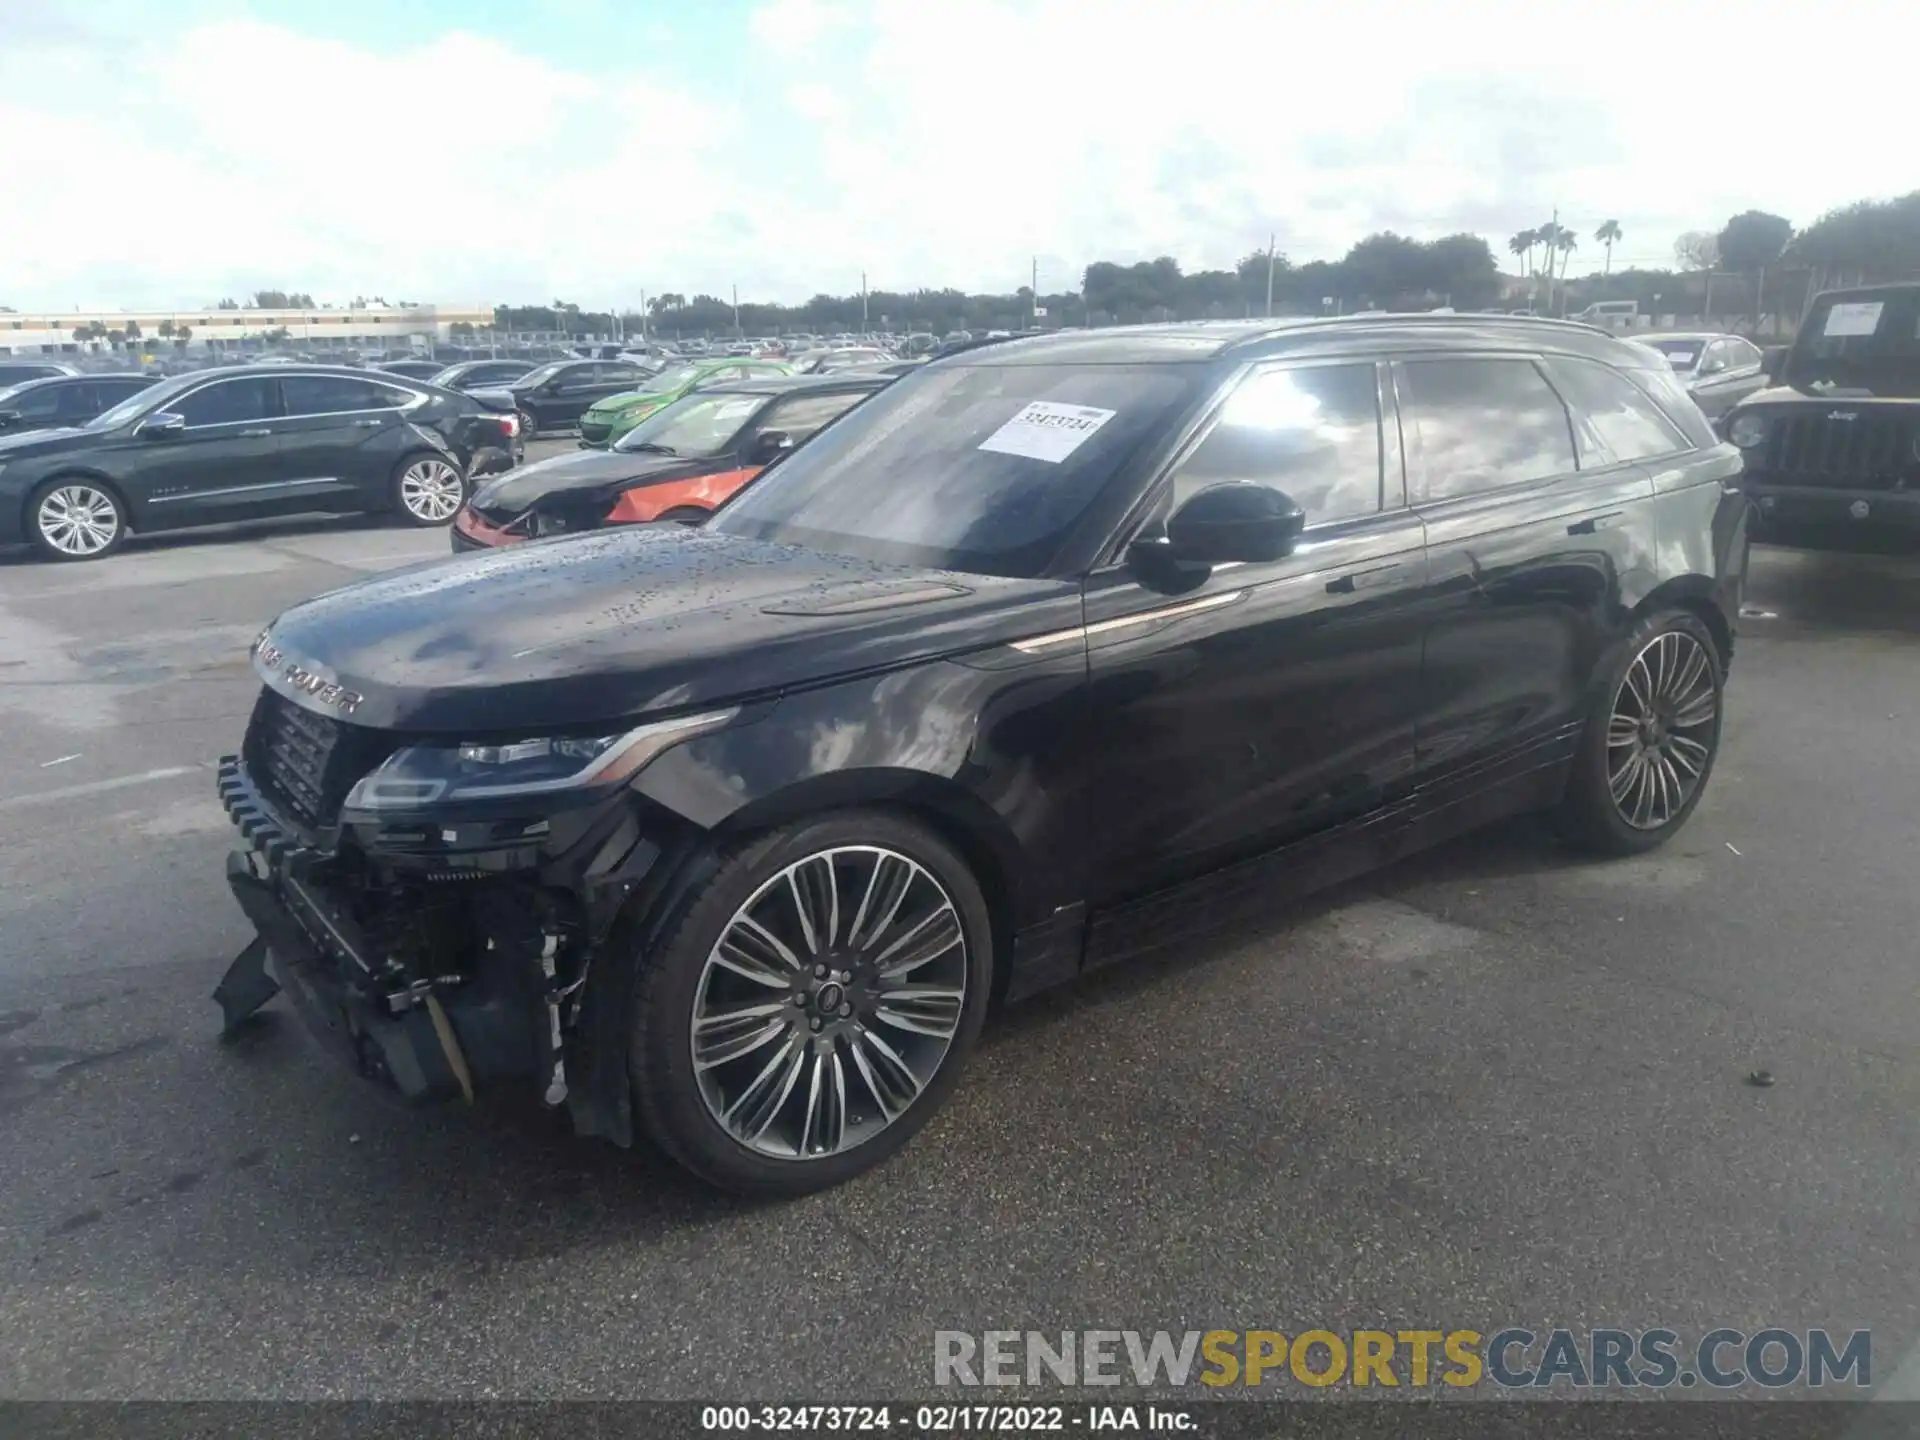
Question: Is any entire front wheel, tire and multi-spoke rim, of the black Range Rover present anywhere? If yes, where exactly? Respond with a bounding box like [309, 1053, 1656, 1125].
[634, 814, 993, 1194]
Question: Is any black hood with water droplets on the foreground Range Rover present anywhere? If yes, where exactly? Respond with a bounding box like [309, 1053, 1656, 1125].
[255, 526, 1073, 735]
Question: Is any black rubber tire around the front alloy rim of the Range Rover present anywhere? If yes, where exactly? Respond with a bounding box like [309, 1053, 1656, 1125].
[628, 810, 993, 1196]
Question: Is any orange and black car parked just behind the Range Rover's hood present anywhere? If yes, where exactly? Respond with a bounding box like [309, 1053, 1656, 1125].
[451, 374, 893, 551]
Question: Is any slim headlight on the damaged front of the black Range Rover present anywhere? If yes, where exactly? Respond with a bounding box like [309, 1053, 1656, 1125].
[348, 707, 739, 810]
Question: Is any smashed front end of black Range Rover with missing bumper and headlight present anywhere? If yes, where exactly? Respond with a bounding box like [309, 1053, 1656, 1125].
[215, 687, 732, 1144]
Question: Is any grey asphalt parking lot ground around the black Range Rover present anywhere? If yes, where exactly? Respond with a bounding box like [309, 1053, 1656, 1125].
[0, 470, 1920, 1400]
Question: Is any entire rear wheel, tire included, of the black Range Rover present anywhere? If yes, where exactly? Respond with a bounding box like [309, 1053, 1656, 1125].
[1555, 611, 1726, 854]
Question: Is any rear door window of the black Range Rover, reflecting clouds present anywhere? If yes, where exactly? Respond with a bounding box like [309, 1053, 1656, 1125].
[1398, 357, 1578, 503]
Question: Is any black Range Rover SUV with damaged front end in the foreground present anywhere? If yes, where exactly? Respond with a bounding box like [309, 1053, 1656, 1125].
[217, 317, 1747, 1192]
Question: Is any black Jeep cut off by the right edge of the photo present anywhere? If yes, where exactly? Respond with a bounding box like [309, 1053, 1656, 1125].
[1720, 284, 1920, 541]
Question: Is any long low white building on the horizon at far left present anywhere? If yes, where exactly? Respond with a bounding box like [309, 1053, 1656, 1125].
[0, 305, 493, 355]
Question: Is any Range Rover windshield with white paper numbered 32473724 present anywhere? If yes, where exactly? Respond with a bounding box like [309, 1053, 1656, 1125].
[712, 365, 1202, 576]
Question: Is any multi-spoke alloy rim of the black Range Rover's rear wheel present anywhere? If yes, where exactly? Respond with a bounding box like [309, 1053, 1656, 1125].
[1607, 630, 1720, 829]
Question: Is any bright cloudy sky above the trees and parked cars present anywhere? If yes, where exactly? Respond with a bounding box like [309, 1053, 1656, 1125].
[0, 0, 1920, 309]
